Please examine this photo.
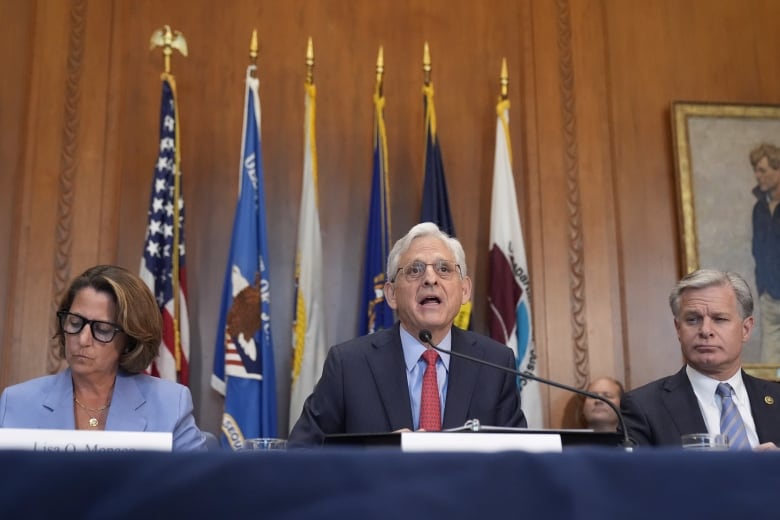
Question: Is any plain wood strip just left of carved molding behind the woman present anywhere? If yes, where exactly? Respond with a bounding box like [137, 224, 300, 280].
[6, 3, 71, 384]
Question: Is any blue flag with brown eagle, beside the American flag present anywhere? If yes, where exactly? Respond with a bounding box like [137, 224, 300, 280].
[211, 65, 277, 450]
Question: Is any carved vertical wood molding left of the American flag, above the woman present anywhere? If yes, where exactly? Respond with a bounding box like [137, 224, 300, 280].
[46, 0, 87, 374]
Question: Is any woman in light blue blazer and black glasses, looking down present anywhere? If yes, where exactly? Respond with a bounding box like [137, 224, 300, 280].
[0, 265, 206, 451]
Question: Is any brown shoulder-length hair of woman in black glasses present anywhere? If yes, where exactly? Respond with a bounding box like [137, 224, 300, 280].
[55, 265, 162, 374]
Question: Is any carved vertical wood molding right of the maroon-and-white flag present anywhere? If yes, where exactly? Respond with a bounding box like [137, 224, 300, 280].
[557, 0, 590, 388]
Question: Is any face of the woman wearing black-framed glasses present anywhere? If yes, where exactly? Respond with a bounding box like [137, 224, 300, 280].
[64, 287, 126, 378]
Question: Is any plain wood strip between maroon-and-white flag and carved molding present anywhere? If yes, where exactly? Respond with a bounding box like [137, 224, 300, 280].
[528, 2, 574, 424]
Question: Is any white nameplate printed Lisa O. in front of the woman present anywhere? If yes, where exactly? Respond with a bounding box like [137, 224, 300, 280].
[0, 428, 173, 453]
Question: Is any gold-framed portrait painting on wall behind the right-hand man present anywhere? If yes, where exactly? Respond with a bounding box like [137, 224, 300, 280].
[671, 101, 780, 379]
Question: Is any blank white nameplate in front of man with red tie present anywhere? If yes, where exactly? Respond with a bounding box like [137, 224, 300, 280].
[401, 432, 563, 453]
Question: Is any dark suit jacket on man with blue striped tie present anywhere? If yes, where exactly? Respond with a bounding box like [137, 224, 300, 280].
[620, 367, 780, 446]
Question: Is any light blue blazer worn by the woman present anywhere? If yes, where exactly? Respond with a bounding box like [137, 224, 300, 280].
[0, 369, 206, 451]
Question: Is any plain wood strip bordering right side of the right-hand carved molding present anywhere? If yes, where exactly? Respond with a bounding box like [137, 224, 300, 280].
[570, 0, 624, 389]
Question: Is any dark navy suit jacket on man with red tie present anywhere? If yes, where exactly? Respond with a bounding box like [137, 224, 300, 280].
[289, 322, 526, 446]
